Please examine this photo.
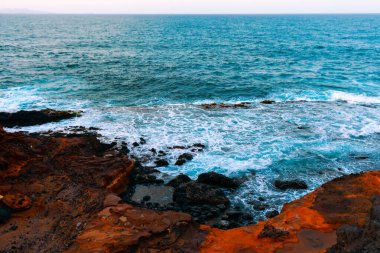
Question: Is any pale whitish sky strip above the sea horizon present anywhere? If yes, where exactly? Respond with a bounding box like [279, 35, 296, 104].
[0, 0, 380, 14]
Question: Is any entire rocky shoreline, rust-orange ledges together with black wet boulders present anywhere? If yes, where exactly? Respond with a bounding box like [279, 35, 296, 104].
[0, 109, 380, 252]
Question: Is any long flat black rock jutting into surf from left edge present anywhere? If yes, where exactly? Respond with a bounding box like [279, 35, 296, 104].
[0, 109, 80, 127]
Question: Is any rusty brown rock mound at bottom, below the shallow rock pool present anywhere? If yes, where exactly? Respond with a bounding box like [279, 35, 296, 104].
[67, 204, 204, 253]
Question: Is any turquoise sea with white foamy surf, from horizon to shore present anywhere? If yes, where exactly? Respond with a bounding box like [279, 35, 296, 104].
[0, 15, 380, 218]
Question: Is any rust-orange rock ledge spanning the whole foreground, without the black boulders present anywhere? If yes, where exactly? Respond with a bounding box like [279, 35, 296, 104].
[0, 128, 380, 253]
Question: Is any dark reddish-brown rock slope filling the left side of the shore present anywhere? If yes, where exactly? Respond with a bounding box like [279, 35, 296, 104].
[0, 128, 134, 252]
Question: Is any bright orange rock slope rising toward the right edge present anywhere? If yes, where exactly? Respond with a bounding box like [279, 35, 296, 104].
[200, 171, 380, 253]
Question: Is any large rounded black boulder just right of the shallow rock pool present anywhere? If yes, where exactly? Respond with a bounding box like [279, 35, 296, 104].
[173, 182, 230, 205]
